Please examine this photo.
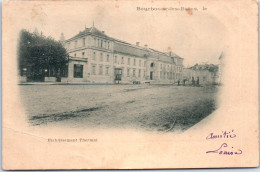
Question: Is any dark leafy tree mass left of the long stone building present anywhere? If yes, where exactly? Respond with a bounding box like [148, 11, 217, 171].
[18, 30, 68, 80]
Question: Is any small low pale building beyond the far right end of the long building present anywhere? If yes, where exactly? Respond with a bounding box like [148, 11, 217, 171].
[183, 64, 218, 85]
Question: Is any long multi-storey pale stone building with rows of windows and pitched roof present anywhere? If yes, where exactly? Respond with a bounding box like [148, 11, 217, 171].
[62, 25, 183, 83]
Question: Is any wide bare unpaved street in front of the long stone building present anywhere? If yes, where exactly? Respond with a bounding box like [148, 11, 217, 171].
[20, 85, 217, 131]
